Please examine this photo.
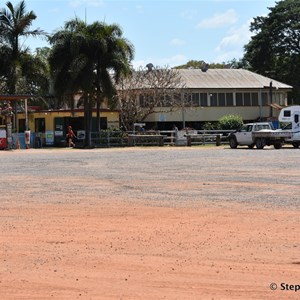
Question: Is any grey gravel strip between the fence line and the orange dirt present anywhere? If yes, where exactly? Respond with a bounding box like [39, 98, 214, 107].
[0, 147, 300, 209]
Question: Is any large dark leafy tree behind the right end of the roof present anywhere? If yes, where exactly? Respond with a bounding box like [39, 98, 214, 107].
[244, 0, 300, 103]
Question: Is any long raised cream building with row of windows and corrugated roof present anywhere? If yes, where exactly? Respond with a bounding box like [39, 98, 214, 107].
[145, 69, 292, 129]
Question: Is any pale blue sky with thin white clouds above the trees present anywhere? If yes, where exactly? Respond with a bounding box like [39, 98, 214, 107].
[7, 0, 279, 68]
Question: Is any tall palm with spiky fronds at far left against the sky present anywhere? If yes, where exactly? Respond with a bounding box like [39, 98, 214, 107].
[0, 1, 45, 125]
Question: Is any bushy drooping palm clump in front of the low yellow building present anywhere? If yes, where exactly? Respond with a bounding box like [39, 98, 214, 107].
[49, 18, 134, 147]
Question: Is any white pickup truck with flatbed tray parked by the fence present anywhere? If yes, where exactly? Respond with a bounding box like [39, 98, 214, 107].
[228, 122, 291, 149]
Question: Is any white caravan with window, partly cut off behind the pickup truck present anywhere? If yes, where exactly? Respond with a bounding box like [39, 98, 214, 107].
[278, 105, 300, 148]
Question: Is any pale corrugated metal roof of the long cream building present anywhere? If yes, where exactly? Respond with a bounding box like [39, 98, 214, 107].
[178, 69, 293, 89]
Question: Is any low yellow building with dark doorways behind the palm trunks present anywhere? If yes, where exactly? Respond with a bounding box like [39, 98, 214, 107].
[0, 95, 119, 148]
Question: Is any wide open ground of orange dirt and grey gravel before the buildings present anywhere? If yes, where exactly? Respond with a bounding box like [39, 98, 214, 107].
[0, 147, 300, 299]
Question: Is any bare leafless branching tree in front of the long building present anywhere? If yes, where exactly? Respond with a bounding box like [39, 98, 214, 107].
[116, 64, 192, 130]
